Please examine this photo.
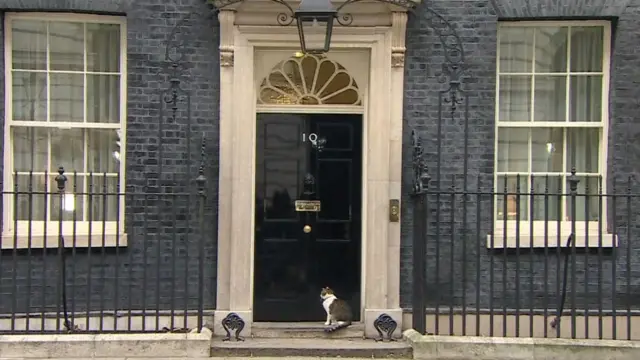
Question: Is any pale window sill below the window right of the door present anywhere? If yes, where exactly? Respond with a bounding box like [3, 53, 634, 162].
[487, 231, 618, 249]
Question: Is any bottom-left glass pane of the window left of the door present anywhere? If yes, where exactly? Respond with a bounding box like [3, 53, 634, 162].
[11, 175, 46, 222]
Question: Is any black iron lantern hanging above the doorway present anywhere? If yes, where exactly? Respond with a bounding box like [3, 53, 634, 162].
[295, 0, 337, 54]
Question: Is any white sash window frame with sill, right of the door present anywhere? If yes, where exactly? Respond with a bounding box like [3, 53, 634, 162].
[486, 20, 618, 249]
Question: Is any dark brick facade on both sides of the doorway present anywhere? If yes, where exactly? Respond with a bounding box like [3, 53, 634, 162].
[0, 0, 640, 320]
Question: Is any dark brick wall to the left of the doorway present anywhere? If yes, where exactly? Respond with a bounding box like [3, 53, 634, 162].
[0, 0, 219, 313]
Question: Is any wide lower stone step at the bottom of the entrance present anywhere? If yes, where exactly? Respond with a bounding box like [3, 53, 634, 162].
[211, 337, 413, 359]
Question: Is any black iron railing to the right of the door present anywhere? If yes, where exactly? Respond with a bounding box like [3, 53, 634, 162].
[411, 160, 640, 339]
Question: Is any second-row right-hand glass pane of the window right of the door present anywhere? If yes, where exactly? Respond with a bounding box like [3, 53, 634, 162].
[569, 75, 602, 121]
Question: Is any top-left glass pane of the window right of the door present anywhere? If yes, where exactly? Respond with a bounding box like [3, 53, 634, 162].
[500, 27, 534, 73]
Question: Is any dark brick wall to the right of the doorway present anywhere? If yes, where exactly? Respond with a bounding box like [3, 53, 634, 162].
[401, 0, 640, 309]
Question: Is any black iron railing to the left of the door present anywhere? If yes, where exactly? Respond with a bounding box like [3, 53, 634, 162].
[0, 166, 210, 334]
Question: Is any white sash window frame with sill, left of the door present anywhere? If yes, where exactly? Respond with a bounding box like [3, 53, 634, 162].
[1, 13, 127, 249]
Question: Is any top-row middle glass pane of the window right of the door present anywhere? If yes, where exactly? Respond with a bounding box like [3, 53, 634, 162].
[535, 26, 569, 73]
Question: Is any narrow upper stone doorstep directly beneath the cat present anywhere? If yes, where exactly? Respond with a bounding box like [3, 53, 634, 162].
[251, 322, 364, 339]
